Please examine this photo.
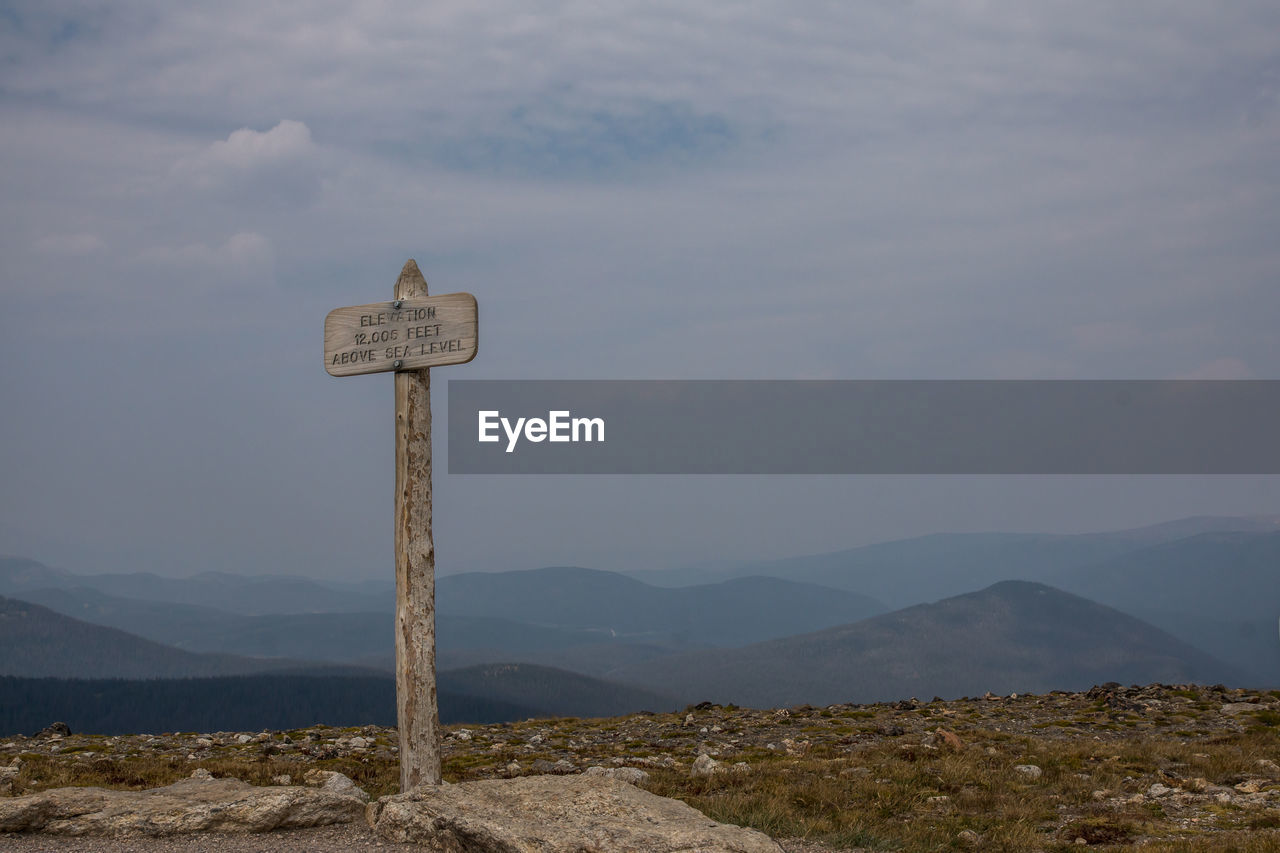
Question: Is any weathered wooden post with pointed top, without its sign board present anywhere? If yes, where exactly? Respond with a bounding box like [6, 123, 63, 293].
[396, 259, 440, 792]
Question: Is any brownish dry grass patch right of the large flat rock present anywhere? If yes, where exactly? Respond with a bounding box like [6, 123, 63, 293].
[634, 730, 1280, 852]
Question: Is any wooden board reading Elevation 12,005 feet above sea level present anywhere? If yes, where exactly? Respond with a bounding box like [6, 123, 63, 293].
[324, 293, 477, 377]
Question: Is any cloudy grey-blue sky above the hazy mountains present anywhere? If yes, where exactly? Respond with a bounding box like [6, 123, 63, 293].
[0, 0, 1280, 579]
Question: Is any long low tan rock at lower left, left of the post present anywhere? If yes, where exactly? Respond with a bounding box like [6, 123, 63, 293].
[0, 779, 365, 835]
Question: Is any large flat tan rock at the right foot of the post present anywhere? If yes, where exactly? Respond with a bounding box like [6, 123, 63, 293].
[366, 776, 782, 853]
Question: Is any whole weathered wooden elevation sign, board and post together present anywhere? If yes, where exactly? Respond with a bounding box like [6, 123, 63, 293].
[324, 259, 477, 790]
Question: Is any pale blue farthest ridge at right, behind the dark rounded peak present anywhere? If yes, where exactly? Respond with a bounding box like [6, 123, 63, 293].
[624, 515, 1280, 684]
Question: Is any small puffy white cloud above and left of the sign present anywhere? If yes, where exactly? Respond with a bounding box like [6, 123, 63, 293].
[173, 119, 320, 204]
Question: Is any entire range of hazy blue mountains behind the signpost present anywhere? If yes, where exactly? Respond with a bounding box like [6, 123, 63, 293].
[0, 517, 1280, 732]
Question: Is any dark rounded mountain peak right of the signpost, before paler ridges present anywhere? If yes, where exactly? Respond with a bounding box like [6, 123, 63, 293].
[613, 581, 1245, 708]
